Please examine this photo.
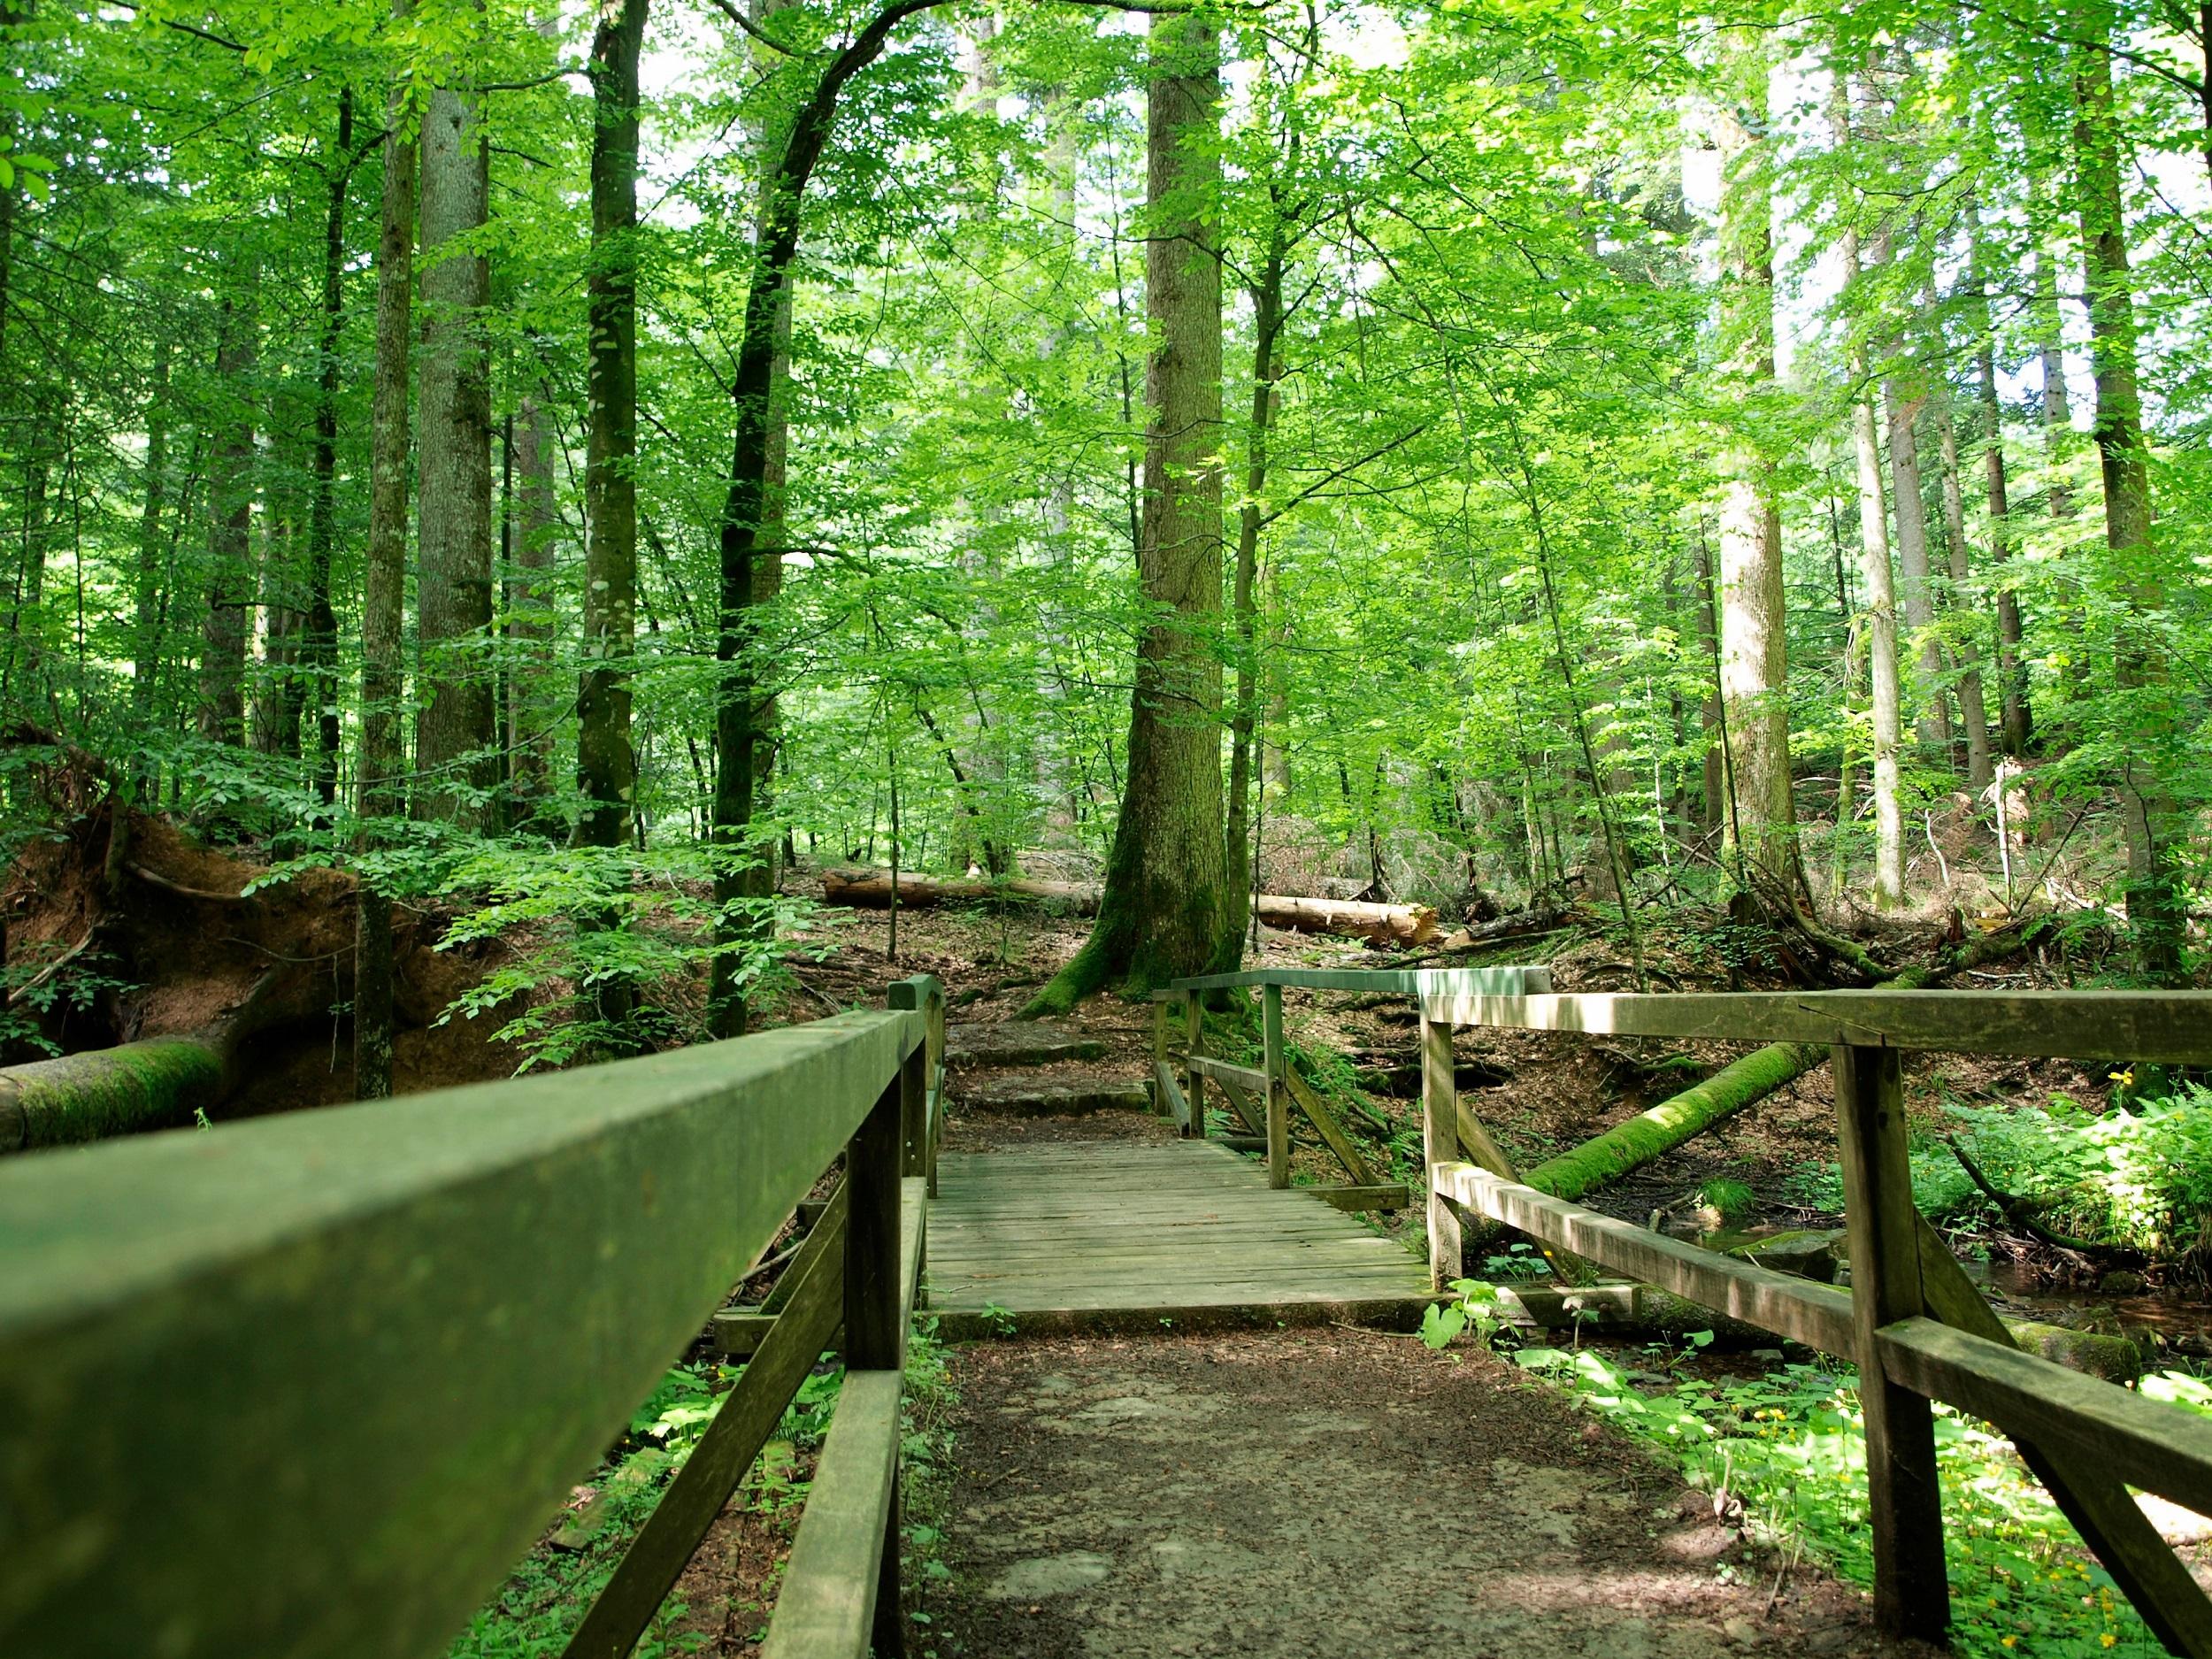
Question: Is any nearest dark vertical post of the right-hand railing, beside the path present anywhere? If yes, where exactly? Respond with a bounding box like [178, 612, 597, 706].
[1832, 1044, 1951, 1644]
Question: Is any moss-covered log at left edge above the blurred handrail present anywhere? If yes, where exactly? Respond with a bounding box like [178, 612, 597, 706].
[0, 1038, 224, 1150]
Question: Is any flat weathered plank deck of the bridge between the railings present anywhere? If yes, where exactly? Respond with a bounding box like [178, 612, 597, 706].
[927, 1141, 1432, 1339]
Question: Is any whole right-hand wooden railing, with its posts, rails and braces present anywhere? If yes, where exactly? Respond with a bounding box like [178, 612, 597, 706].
[1155, 972, 2212, 1657]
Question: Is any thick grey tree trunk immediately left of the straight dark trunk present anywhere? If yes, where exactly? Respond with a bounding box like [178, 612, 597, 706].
[414, 87, 495, 827]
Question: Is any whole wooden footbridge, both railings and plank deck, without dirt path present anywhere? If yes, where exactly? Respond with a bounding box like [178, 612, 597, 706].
[12, 972, 2212, 1659]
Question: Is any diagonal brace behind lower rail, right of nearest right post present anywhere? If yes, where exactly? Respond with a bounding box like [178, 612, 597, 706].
[1918, 1217, 2212, 1659]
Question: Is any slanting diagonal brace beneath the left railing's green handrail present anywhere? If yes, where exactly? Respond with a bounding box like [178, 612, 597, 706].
[565, 1217, 845, 1659]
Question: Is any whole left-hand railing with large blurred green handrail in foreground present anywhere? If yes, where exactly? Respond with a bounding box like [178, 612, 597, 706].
[0, 980, 945, 1659]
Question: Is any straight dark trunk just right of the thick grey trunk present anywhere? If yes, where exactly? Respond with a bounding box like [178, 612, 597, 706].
[575, 0, 646, 848]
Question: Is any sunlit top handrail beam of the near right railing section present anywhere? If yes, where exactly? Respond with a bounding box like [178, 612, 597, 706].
[1425, 991, 2212, 1066]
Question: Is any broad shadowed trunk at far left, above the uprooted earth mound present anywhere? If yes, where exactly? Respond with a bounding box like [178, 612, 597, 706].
[199, 257, 261, 743]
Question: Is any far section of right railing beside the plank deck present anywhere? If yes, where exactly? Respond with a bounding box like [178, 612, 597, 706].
[1153, 967, 1551, 1210]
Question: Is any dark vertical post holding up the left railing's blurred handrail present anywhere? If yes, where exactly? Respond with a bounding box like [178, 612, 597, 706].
[845, 1066, 911, 1659]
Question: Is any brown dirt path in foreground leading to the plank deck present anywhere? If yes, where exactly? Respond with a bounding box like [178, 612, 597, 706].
[914, 1330, 1874, 1659]
